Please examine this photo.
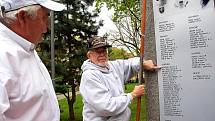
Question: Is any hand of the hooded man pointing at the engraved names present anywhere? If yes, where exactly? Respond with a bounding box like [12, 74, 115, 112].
[143, 60, 160, 71]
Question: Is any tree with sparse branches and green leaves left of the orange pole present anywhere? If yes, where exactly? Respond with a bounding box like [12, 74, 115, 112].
[96, 0, 141, 55]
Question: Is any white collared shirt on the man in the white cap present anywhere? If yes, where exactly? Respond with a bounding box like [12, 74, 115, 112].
[0, 23, 60, 121]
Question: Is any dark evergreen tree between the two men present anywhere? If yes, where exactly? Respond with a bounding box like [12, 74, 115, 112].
[38, 0, 102, 121]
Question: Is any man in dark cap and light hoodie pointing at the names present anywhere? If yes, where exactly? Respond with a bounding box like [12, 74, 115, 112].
[80, 37, 157, 121]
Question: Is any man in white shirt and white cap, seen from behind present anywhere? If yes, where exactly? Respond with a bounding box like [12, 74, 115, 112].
[0, 0, 64, 121]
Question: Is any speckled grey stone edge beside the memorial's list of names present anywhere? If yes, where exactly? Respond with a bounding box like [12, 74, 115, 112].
[144, 0, 160, 121]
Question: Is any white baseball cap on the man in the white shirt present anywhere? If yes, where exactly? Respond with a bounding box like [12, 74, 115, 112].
[0, 0, 65, 12]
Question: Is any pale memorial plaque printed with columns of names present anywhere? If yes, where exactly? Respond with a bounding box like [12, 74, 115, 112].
[153, 0, 215, 121]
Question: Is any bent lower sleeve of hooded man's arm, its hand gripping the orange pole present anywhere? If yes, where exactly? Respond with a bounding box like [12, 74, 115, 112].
[80, 71, 132, 116]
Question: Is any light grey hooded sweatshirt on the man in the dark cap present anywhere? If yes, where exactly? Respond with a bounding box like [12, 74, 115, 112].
[80, 58, 139, 121]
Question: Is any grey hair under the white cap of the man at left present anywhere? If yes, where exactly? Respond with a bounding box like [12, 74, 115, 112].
[0, 5, 41, 24]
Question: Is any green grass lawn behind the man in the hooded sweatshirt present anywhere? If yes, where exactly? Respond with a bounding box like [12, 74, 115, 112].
[59, 83, 146, 121]
